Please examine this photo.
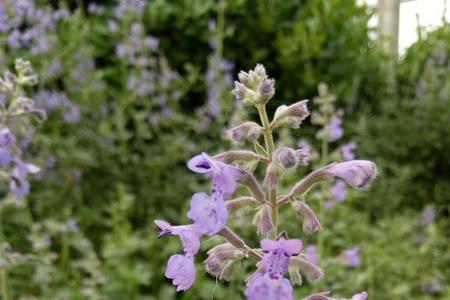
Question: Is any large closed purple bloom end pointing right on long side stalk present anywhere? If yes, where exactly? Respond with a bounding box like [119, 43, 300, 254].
[327, 160, 377, 190]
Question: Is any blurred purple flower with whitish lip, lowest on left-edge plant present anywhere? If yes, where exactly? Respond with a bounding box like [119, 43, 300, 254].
[9, 161, 40, 198]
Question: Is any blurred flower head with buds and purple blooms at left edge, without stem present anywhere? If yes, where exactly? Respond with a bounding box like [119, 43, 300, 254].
[0, 59, 46, 198]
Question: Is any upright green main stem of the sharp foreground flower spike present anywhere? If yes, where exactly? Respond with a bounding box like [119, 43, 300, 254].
[256, 104, 278, 238]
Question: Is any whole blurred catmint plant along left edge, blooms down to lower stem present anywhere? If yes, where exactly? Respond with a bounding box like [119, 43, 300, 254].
[0, 59, 46, 300]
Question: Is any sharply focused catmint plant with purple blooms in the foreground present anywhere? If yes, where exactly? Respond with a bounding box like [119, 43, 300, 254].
[155, 65, 377, 300]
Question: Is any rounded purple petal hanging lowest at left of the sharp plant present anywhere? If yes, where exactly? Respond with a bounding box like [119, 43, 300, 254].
[165, 254, 197, 292]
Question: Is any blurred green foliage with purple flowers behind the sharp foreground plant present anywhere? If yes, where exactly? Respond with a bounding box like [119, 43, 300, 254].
[0, 0, 450, 300]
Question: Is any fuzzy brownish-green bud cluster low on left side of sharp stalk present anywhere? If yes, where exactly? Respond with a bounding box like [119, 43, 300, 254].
[203, 243, 244, 281]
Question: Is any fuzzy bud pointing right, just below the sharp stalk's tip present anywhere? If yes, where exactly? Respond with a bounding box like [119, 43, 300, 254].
[270, 100, 309, 129]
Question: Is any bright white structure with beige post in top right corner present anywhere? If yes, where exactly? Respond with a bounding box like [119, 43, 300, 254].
[360, 0, 450, 55]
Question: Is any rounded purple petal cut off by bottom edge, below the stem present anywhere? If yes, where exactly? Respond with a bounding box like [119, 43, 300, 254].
[245, 275, 294, 300]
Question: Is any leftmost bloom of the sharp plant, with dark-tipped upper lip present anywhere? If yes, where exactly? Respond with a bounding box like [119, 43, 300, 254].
[154, 220, 201, 256]
